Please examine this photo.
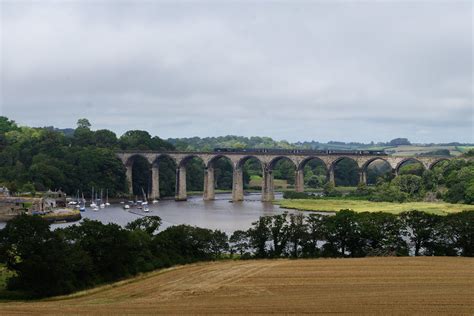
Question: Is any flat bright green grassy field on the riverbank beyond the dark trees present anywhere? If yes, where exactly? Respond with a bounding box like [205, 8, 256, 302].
[275, 199, 474, 215]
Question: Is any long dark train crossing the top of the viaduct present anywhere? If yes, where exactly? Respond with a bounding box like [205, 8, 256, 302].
[214, 148, 388, 156]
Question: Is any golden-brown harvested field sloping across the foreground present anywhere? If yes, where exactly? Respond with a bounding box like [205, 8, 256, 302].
[0, 257, 474, 315]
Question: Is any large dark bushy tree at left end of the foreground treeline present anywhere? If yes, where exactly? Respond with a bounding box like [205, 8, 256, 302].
[0, 215, 92, 297]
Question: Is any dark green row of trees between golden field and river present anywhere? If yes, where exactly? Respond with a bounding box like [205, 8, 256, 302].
[0, 210, 474, 297]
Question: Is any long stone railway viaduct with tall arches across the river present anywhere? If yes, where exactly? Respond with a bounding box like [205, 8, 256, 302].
[117, 151, 449, 202]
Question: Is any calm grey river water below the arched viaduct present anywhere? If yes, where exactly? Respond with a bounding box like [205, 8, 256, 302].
[0, 193, 300, 233]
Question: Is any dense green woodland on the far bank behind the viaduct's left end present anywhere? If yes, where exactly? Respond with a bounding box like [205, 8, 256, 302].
[0, 117, 174, 196]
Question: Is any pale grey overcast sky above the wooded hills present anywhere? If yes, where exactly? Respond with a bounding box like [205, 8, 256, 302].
[0, 0, 474, 143]
